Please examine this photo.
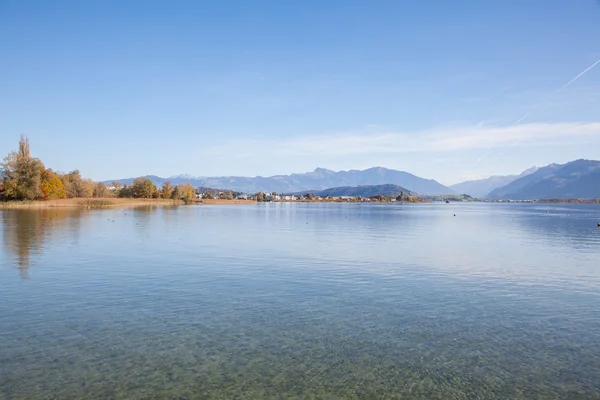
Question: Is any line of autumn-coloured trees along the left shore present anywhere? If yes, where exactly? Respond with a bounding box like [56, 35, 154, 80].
[0, 135, 196, 202]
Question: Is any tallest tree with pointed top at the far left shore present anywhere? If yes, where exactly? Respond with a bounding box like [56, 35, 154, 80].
[2, 135, 44, 200]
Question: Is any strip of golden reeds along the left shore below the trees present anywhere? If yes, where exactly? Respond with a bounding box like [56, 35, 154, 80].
[0, 197, 183, 209]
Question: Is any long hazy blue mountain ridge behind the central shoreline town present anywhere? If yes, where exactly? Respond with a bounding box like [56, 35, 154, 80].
[106, 167, 454, 195]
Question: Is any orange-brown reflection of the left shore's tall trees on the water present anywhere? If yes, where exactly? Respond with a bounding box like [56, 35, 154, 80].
[0, 208, 84, 279]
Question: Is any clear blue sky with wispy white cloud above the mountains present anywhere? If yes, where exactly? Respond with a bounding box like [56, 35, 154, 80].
[0, 0, 600, 184]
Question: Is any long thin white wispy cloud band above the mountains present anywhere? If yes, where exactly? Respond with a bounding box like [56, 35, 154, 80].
[205, 118, 600, 159]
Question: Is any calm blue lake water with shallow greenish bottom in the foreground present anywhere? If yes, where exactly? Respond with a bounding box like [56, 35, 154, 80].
[0, 203, 600, 399]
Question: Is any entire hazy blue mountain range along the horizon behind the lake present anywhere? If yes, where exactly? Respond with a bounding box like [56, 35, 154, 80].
[103, 160, 600, 200]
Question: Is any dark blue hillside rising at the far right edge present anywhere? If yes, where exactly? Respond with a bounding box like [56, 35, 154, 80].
[487, 160, 600, 200]
